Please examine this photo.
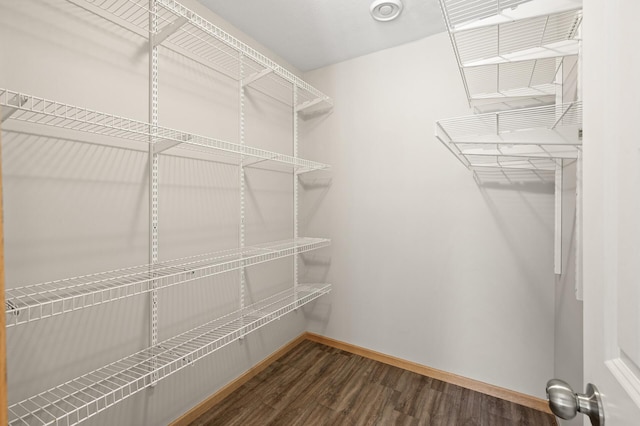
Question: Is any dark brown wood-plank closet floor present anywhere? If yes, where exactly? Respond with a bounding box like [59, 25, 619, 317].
[191, 340, 557, 426]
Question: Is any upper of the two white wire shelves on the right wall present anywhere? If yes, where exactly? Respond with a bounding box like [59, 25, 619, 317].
[440, 0, 582, 111]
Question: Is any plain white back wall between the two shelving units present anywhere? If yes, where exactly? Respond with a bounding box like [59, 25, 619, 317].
[304, 33, 554, 397]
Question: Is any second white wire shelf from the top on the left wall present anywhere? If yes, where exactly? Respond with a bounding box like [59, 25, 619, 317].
[0, 88, 330, 173]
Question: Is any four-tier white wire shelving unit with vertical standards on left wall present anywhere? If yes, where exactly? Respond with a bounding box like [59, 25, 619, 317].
[0, 0, 333, 426]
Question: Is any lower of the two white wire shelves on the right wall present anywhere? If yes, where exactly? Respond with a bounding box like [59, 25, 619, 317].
[436, 102, 582, 171]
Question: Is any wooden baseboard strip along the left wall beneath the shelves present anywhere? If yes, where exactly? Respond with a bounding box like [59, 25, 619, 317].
[169, 333, 307, 426]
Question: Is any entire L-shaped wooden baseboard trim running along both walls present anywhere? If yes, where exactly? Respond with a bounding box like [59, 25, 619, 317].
[169, 332, 552, 426]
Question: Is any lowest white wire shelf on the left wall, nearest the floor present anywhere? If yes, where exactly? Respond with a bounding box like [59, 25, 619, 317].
[9, 284, 331, 426]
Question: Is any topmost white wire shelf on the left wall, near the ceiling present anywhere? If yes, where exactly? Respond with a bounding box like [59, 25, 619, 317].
[73, 0, 333, 111]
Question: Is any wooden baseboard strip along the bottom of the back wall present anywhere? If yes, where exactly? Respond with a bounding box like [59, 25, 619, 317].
[305, 332, 552, 414]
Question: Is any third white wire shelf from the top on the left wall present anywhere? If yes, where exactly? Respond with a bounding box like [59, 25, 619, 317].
[5, 238, 330, 327]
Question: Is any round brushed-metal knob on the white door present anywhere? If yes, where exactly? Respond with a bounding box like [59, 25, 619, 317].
[547, 379, 604, 426]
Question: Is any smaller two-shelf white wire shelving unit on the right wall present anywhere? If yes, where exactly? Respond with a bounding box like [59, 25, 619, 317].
[435, 0, 582, 274]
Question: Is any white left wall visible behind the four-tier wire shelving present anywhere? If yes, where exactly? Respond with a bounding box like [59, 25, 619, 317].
[0, 0, 306, 426]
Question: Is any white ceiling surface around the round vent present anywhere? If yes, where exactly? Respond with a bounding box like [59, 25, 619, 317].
[199, 0, 445, 71]
